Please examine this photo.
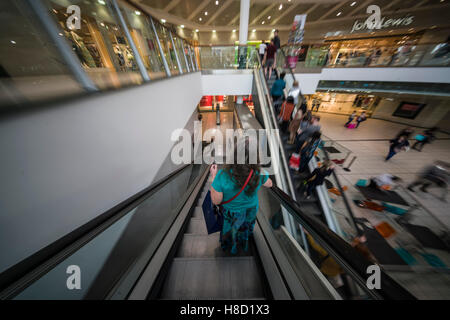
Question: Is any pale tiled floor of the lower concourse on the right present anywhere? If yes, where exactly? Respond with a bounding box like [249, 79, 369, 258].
[312, 112, 450, 299]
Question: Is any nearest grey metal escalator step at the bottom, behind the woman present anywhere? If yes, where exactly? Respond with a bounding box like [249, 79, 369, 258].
[161, 257, 264, 299]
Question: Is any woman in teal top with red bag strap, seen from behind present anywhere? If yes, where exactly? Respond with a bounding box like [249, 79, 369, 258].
[210, 139, 272, 254]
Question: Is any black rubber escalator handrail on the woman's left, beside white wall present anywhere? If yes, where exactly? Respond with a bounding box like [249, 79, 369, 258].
[0, 162, 199, 300]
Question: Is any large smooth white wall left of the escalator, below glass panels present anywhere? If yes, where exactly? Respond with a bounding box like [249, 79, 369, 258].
[0, 72, 202, 272]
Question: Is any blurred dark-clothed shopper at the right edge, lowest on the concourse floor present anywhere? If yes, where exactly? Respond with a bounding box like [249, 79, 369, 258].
[408, 161, 450, 201]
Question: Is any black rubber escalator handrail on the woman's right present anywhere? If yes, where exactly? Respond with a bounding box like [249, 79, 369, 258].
[271, 186, 416, 300]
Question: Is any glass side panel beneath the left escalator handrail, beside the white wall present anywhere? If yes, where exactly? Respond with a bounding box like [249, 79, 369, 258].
[15, 165, 207, 300]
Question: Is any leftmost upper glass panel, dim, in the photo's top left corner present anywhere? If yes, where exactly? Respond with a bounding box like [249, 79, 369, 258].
[0, 0, 83, 106]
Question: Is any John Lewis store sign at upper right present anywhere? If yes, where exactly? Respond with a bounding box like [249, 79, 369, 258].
[350, 5, 414, 33]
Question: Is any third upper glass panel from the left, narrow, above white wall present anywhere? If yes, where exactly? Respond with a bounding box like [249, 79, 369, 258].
[119, 1, 166, 79]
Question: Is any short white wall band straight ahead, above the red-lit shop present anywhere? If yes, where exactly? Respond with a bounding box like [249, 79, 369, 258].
[202, 70, 253, 96]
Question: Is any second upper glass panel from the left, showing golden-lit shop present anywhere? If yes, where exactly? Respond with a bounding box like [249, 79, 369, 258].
[46, 0, 143, 88]
